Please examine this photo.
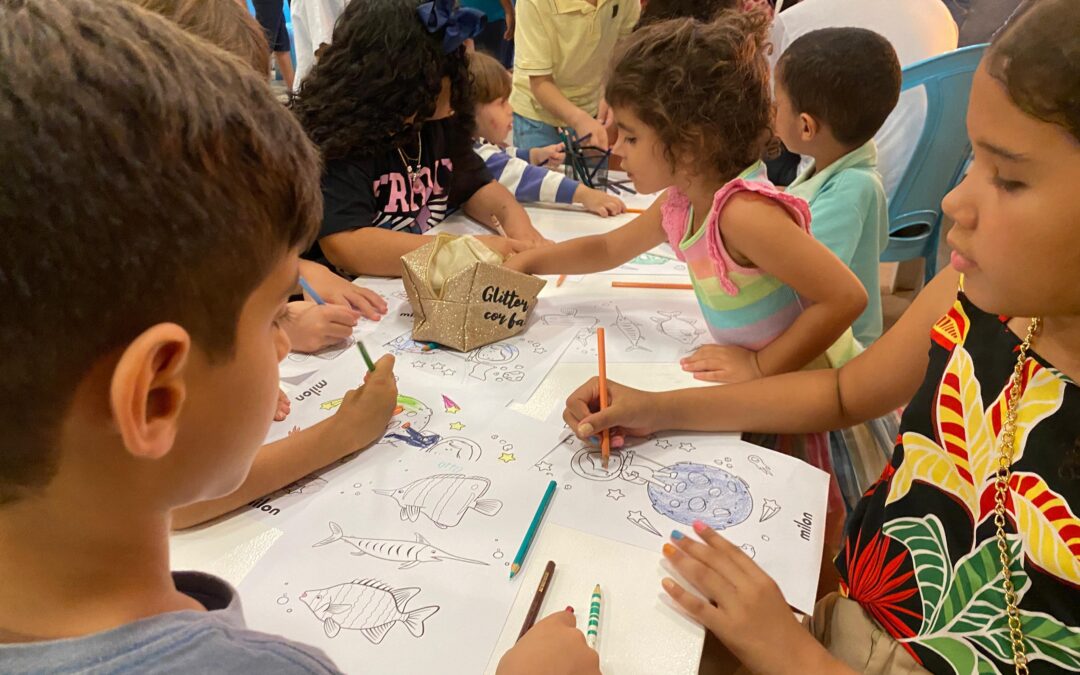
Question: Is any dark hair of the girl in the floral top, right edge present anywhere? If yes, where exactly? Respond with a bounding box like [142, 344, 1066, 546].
[986, 0, 1080, 139]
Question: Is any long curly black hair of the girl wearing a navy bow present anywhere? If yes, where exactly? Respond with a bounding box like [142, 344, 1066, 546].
[289, 0, 475, 160]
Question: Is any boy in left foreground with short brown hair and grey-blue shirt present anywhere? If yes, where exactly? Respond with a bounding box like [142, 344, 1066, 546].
[0, 0, 598, 675]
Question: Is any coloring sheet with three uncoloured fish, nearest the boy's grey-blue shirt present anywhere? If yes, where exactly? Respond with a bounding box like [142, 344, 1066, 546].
[240, 453, 549, 675]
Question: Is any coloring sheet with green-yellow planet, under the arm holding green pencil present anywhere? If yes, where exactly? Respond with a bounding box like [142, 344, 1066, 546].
[248, 382, 564, 527]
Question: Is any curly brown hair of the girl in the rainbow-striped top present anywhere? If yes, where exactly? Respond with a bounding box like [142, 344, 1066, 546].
[605, 10, 772, 180]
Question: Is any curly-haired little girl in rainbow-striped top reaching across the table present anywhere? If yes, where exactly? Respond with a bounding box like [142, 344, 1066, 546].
[507, 11, 866, 382]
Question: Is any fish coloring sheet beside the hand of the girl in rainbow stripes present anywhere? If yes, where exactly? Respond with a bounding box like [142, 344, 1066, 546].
[534, 288, 712, 363]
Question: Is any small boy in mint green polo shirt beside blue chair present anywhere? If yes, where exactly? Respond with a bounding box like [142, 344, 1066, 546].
[774, 28, 901, 347]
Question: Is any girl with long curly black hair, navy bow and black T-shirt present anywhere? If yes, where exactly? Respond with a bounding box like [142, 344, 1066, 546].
[292, 0, 543, 276]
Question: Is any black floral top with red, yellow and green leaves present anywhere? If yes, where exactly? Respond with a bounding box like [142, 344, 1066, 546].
[836, 292, 1080, 675]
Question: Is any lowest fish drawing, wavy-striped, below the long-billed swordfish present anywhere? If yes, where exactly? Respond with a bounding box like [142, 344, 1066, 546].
[300, 579, 438, 645]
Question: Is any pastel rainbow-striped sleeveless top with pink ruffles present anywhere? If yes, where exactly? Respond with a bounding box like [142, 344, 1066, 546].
[661, 162, 810, 351]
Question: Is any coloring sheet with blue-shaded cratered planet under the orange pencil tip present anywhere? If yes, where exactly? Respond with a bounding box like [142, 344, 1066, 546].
[532, 434, 828, 612]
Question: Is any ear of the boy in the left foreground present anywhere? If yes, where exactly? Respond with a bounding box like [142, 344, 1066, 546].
[109, 323, 191, 459]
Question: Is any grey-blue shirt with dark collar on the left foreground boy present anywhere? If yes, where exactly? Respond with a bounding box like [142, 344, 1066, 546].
[0, 572, 340, 675]
